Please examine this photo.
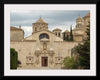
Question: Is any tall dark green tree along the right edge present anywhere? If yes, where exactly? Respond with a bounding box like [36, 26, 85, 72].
[76, 21, 90, 69]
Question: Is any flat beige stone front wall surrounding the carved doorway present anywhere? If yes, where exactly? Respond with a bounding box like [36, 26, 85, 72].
[10, 41, 79, 69]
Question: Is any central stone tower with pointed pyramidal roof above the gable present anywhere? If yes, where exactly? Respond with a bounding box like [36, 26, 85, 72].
[32, 17, 48, 33]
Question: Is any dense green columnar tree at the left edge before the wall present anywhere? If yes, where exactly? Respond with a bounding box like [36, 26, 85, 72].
[10, 48, 18, 69]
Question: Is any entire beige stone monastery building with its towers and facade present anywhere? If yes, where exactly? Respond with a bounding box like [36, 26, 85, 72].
[10, 13, 90, 69]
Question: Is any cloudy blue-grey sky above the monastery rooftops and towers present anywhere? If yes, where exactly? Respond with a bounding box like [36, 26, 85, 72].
[10, 10, 89, 37]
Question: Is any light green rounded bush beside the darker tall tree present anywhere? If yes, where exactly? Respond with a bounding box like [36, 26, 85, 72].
[63, 57, 79, 69]
